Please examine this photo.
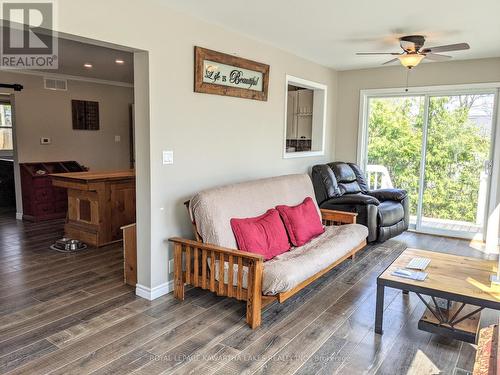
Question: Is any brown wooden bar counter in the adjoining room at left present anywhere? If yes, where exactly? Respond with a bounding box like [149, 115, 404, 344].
[51, 170, 135, 247]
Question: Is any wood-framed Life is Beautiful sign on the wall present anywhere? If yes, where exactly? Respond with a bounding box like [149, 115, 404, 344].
[194, 47, 269, 101]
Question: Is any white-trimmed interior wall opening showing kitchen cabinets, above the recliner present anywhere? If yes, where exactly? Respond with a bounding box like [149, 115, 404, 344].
[284, 76, 326, 158]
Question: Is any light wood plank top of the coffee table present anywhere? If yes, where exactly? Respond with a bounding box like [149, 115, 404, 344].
[379, 248, 500, 302]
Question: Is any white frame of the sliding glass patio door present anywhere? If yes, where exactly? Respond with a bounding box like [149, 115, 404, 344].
[356, 82, 500, 244]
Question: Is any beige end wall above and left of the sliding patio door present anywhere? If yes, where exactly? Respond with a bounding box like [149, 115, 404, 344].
[335, 58, 500, 161]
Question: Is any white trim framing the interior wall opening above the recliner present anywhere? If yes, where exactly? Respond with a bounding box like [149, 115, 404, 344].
[283, 74, 328, 159]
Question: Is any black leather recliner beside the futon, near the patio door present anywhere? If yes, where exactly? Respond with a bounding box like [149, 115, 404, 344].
[312, 162, 410, 242]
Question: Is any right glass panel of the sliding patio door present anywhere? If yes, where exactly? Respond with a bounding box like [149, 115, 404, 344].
[420, 94, 495, 238]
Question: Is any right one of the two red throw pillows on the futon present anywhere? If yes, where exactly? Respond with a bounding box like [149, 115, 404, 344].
[276, 197, 325, 246]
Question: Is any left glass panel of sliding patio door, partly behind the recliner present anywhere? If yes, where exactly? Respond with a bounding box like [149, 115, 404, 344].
[366, 96, 425, 227]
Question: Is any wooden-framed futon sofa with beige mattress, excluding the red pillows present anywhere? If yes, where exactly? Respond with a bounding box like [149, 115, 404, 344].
[170, 174, 368, 328]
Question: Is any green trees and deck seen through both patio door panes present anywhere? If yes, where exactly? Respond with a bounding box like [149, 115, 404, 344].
[367, 95, 494, 235]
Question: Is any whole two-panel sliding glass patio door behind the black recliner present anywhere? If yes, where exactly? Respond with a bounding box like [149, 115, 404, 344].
[359, 88, 497, 240]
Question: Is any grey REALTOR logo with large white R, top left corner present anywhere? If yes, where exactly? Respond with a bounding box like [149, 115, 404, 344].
[0, 1, 58, 69]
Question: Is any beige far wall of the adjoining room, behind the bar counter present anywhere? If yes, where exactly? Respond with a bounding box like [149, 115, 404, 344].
[7, 72, 134, 170]
